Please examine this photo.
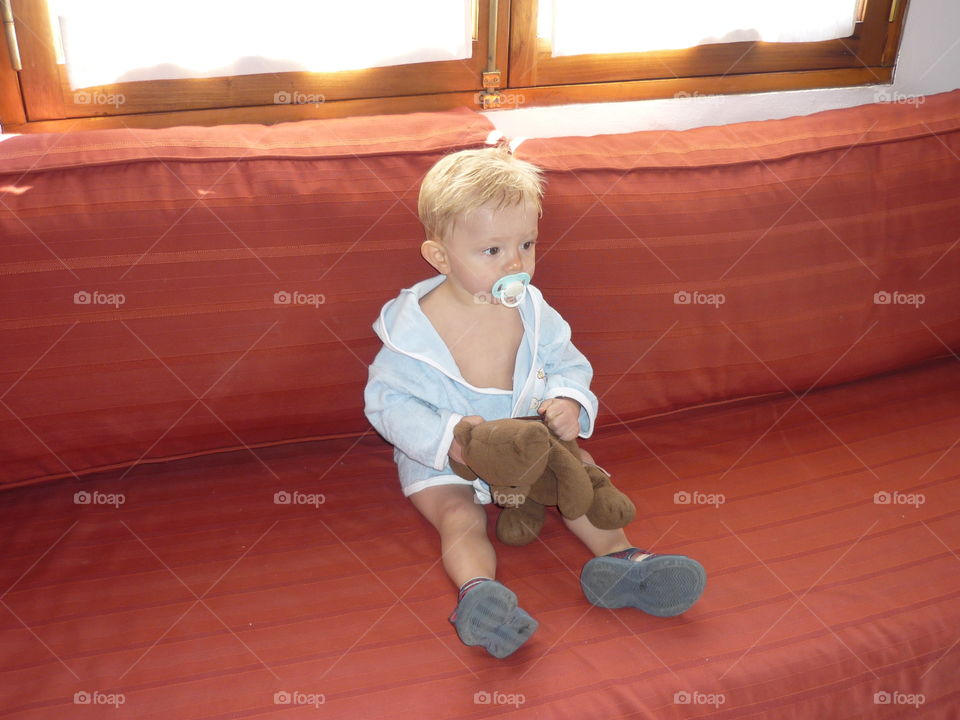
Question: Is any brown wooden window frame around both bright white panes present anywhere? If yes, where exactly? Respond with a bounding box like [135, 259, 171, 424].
[0, 0, 908, 132]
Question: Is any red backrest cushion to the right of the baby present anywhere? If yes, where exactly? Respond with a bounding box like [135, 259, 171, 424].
[517, 91, 960, 424]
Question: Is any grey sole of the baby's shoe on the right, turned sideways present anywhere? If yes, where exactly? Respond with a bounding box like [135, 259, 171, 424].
[580, 555, 707, 617]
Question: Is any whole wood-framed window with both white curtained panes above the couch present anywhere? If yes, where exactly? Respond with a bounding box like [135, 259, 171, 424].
[0, 0, 908, 132]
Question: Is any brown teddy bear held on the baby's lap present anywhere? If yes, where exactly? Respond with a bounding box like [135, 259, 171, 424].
[450, 418, 636, 545]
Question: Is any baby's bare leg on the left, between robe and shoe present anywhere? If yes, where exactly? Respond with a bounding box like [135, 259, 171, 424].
[410, 485, 497, 588]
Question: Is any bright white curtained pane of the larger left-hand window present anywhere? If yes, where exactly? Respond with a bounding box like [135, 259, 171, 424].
[50, 0, 473, 89]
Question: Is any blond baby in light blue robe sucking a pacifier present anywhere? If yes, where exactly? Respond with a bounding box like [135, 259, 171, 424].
[365, 146, 706, 658]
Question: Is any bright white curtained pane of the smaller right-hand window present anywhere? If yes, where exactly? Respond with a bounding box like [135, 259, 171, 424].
[537, 0, 858, 57]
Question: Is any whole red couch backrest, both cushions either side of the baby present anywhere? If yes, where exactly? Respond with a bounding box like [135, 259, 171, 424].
[7, 92, 960, 485]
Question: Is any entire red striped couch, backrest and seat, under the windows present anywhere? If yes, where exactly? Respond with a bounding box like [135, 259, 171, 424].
[0, 92, 960, 720]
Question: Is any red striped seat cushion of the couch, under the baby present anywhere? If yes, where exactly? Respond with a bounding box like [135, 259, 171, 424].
[0, 358, 960, 720]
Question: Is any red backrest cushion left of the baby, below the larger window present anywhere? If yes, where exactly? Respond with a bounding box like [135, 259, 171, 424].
[0, 110, 492, 485]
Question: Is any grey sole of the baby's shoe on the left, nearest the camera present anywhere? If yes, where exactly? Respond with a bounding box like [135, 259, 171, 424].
[454, 581, 539, 659]
